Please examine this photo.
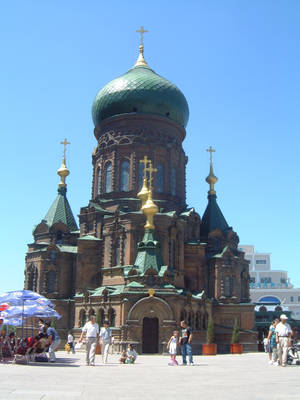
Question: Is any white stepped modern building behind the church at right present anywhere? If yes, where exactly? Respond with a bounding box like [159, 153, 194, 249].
[239, 245, 300, 320]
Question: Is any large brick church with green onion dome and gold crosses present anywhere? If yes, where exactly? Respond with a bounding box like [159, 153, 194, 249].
[25, 27, 256, 353]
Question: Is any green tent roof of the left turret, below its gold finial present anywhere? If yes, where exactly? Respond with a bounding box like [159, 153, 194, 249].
[44, 187, 78, 231]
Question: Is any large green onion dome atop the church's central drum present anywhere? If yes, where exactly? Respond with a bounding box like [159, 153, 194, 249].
[92, 63, 189, 127]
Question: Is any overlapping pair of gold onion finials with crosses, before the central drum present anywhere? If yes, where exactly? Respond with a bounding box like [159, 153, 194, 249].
[138, 156, 158, 229]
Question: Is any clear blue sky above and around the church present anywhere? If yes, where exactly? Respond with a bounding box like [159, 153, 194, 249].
[0, 0, 300, 292]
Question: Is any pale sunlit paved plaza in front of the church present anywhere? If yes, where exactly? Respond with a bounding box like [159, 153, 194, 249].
[0, 351, 300, 400]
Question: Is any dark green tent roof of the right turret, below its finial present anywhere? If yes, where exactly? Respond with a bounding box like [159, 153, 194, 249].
[201, 194, 230, 236]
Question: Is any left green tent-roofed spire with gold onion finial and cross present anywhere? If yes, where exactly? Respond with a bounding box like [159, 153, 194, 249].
[44, 139, 78, 231]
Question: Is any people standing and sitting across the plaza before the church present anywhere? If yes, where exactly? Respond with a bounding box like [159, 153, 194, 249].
[0, 314, 298, 367]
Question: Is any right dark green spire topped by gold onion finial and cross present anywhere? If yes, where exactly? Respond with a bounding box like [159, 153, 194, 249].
[201, 146, 230, 236]
